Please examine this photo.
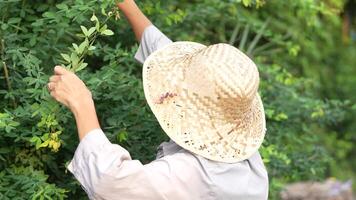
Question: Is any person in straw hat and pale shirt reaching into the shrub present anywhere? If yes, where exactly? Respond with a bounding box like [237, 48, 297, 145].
[48, 0, 268, 200]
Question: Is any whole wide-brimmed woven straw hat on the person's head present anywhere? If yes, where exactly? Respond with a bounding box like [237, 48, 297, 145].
[143, 42, 266, 163]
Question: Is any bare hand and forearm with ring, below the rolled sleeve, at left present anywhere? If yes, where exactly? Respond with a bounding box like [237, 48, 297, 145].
[48, 66, 100, 140]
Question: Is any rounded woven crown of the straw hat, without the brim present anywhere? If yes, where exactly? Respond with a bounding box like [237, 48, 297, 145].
[185, 43, 259, 104]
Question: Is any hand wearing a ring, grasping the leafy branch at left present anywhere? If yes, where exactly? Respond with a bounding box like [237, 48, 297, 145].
[48, 66, 92, 111]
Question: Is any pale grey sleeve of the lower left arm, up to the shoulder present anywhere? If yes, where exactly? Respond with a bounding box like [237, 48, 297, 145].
[68, 129, 214, 200]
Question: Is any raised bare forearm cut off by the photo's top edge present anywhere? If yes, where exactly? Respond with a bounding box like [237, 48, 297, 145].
[117, 0, 151, 42]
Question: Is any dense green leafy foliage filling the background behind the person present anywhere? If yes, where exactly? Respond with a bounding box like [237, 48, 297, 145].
[0, 0, 356, 199]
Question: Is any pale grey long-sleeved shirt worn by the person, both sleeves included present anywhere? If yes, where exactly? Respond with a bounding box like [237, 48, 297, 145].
[68, 25, 268, 200]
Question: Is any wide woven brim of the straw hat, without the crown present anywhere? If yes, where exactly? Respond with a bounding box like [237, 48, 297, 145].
[143, 42, 266, 163]
